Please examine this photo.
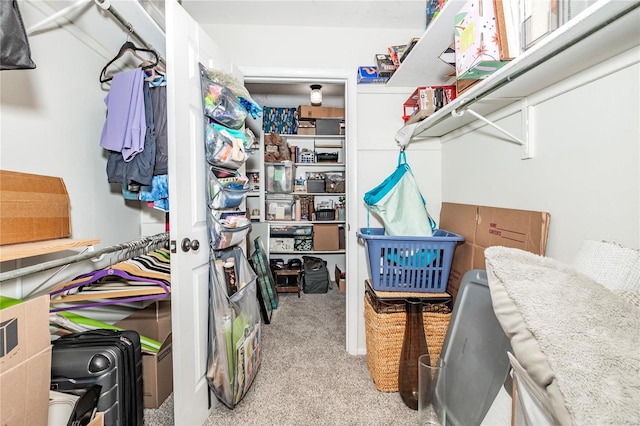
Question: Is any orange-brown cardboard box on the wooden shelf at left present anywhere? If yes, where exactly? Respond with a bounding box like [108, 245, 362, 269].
[0, 170, 71, 245]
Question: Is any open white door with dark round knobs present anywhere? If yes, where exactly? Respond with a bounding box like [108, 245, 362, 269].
[165, 0, 228, 425]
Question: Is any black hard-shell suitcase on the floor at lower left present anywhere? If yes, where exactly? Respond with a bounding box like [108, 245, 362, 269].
[51, 330, 144, 426]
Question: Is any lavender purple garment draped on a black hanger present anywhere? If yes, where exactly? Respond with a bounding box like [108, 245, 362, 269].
[100, 68, 147, 161]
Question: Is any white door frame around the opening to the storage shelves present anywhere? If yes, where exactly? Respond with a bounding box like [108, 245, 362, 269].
[241, 67, 364, 355]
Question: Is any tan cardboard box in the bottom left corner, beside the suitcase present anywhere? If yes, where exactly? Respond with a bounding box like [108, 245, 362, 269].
[0, 296, 51, 426]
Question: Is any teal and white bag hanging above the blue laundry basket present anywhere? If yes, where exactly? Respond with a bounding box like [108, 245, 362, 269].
[364, 150, 436, 237]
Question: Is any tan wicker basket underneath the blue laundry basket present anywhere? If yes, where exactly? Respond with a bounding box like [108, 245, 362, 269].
[364, 293, 451, 392]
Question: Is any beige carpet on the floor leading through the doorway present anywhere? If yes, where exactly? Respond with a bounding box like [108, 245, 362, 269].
[145, 285, 418, 426]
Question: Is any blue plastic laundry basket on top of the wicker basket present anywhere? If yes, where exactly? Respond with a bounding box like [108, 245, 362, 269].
[357, 228, 464, 293]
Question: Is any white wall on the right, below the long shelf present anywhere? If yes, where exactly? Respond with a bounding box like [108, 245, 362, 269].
[442, 48, 640, 263]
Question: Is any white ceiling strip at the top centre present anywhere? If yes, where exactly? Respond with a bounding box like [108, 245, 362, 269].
[181, 0, 426, 29]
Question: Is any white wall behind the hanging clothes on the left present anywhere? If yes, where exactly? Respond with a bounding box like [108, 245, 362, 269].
[0, 2, 152, 295]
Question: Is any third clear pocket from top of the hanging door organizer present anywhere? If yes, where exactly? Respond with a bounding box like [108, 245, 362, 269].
[207, 166, 249, 209]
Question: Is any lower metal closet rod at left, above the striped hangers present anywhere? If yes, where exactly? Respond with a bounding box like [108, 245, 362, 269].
[0, 232, 169, 282]
